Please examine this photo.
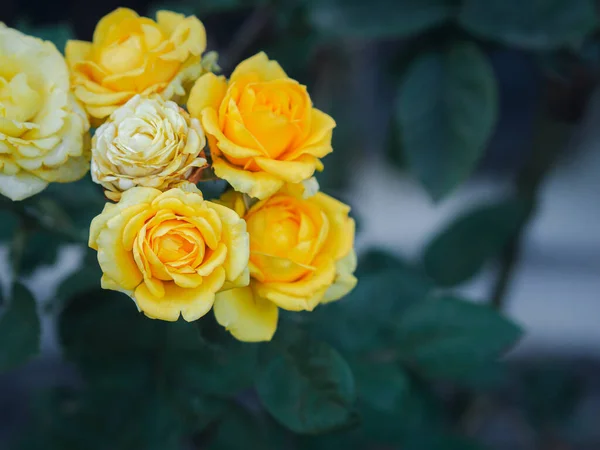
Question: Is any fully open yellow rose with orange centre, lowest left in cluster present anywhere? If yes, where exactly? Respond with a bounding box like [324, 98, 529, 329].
[89, 183, 249, 322]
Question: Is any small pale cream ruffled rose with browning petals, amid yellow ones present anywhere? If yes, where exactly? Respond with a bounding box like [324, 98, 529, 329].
[91, 95, 206, 201]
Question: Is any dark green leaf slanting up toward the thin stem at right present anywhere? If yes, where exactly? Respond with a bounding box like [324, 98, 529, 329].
[424, 198, 531, 286]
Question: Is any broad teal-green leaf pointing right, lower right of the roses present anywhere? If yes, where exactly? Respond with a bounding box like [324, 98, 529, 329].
[397, 296, 522, 378]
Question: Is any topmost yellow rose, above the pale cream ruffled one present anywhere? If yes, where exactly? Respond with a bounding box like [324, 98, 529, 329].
[65, 8, 206, 122]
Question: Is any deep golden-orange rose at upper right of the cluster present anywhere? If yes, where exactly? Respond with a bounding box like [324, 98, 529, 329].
[187, 53, 335, 199]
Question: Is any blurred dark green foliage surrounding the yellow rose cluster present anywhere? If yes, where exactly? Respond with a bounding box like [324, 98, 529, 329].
[0, 0, 600, 450]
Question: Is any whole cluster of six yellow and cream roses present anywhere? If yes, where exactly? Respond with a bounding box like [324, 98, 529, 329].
[0, 8, 356, 341]
